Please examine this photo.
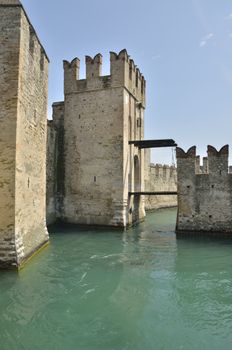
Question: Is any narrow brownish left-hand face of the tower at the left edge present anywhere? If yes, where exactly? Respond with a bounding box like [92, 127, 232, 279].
[0, 2, 20, 265]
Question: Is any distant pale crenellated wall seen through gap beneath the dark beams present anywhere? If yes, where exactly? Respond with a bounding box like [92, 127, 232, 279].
[145, 150, 177, 211]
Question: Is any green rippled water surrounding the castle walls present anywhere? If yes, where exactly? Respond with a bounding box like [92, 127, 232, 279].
[0, 209, 232, 350]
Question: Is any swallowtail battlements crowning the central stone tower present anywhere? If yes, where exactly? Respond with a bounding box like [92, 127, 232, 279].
[63, 49, 146, 106]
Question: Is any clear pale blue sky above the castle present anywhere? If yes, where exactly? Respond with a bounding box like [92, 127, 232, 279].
[22, 0, 232, 164]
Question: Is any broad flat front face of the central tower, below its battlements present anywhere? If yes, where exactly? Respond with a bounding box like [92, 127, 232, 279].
[64, 84, 123, 225]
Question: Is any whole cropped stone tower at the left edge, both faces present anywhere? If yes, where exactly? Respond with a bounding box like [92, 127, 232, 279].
[0, 0, 48, 267]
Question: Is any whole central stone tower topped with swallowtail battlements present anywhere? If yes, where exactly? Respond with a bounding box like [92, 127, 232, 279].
[53, 50, 145, 227]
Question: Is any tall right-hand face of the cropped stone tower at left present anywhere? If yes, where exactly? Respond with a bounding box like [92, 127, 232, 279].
[15, 6, 48, 257]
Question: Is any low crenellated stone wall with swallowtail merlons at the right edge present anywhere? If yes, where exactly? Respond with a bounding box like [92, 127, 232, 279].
[176, 145, 232, 234]
